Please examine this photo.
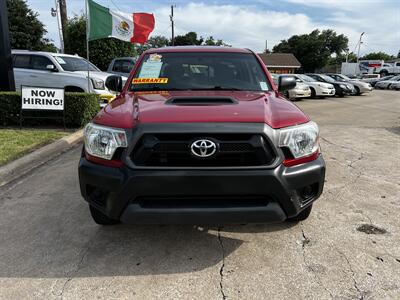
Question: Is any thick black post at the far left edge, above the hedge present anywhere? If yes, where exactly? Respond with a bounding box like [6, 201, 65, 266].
[0, 0, 15, 91]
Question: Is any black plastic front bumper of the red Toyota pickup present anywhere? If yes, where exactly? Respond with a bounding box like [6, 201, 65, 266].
[79, 156, 325, 224]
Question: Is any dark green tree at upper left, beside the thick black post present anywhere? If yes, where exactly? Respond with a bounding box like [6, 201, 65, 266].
[7, 0, 57, 52]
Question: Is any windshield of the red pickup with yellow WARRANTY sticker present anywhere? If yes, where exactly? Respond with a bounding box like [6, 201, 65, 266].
[130, 52, 271, 91]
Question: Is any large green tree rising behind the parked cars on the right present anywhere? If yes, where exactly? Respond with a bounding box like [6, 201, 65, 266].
[272, 29, 348, 72]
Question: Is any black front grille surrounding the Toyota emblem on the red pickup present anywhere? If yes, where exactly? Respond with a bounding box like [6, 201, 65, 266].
[131, 133, 275, 167]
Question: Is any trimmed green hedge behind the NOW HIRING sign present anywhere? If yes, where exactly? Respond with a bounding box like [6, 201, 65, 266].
[0, 92, 100, 127]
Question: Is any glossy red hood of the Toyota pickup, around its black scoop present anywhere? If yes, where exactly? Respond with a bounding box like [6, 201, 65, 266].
[94, 91, 309, 128]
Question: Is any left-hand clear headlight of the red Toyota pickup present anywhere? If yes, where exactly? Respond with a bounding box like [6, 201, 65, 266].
[84, 123, 128, 160]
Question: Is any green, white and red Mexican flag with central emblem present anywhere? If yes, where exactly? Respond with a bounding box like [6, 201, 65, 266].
[87, 0, 155, 44]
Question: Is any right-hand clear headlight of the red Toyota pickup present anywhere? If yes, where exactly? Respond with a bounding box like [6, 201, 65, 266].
[279, 121, 319, 159]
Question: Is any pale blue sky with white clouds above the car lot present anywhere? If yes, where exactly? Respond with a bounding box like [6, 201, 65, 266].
[27, 0, 400, 55]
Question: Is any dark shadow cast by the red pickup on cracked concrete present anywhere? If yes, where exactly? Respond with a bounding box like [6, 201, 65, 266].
[0, 216, 294, 278]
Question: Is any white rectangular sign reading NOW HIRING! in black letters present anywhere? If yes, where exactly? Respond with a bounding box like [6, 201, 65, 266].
[21, 86, 64, 110]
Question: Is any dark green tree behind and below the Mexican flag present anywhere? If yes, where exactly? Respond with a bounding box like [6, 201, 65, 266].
[65, 16, 137, 70]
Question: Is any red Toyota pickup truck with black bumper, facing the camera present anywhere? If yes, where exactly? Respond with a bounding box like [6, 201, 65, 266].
[79, 46, 325, 225]
